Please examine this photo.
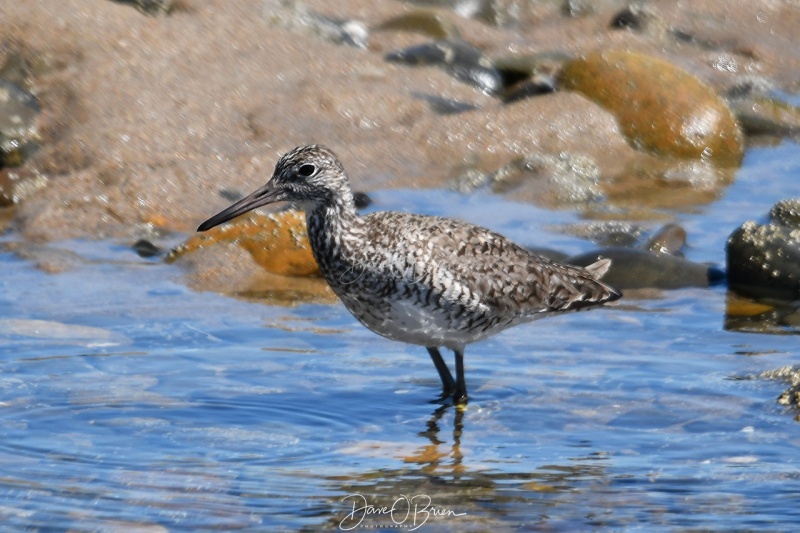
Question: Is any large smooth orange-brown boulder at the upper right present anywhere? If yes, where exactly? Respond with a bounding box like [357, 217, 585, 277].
[559, 51, 743, 166]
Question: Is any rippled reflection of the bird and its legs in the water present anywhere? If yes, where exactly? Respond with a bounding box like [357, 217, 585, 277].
[309, 403, 614, 531]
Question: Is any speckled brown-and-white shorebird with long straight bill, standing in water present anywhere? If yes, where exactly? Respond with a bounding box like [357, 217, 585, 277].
[197, 145, 621, 403]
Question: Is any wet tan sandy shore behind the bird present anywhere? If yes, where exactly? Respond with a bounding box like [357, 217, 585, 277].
[0, 0, 800, 241]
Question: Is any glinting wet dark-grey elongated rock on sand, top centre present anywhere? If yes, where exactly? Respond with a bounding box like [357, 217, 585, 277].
[384, 39, 503, 94]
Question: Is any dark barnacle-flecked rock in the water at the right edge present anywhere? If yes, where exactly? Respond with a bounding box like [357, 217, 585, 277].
[725, 199, 800, 301]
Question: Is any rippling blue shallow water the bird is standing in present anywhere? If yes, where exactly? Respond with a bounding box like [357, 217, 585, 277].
[0, 143, 800, 531]
